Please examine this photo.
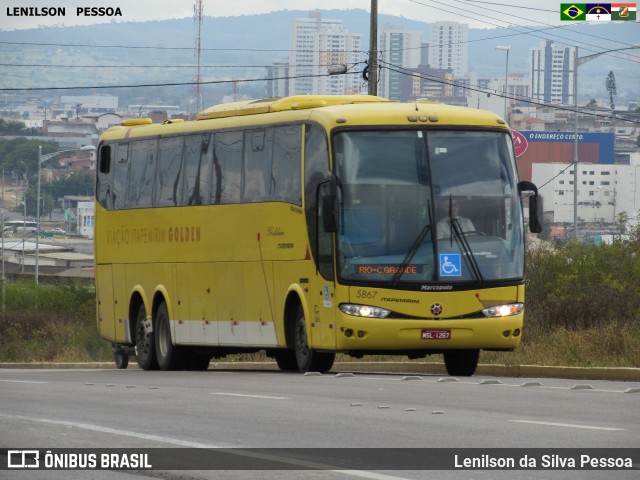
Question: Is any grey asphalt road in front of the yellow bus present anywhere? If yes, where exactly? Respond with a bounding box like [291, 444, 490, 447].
[0, 369, 640, 480]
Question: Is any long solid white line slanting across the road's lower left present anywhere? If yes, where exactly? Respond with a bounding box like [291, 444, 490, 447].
[0, 413, 405, 480]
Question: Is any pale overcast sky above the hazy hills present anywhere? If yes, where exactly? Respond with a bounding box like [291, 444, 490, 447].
[0, 0, 570, 30]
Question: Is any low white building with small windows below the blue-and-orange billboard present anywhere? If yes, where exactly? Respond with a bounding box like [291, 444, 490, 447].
[532, 153, 640, 224]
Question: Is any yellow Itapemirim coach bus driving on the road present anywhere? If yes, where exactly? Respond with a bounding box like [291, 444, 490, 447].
[95, 95, 539, 375]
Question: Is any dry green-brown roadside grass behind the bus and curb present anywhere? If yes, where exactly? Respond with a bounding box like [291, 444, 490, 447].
[0, 272, 640, 367]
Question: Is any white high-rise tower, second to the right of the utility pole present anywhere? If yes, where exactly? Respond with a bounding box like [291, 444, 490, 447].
[429, 22, 469, 78]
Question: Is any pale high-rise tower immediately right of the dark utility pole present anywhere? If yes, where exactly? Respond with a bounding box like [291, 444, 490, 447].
[378, 24, 422, 100]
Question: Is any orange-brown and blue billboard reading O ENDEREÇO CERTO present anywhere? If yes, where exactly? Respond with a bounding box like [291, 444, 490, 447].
[513, 130, 615, 181]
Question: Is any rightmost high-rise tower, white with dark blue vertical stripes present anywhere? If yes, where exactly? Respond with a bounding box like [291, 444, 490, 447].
[530, 40, 575, 105]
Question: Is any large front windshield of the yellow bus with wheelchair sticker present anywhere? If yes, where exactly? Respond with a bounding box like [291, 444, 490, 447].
[334, 130, 524, 288]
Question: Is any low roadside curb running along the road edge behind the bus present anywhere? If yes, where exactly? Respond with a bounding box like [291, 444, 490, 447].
[0, 362, 640, 382]
